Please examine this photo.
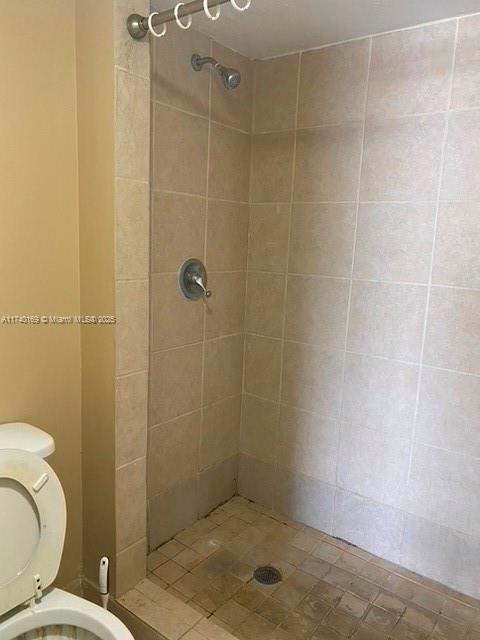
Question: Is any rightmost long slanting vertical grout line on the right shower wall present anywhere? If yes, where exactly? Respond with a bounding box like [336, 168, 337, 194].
[400, 18, 460, 552]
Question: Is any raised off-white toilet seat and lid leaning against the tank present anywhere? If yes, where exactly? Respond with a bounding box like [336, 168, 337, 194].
[0, 449, 66, 616]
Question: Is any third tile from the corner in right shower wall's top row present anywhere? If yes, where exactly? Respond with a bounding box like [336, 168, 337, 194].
[368, 20, 456, 117]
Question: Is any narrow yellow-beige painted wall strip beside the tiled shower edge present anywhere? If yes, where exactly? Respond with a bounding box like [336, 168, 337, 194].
[76, 0, 115, 581]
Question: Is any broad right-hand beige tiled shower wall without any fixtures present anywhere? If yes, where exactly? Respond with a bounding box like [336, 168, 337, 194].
[242, 16, 480, 597]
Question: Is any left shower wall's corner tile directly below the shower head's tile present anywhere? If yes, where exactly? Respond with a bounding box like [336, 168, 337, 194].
[209, 123, 250, 202]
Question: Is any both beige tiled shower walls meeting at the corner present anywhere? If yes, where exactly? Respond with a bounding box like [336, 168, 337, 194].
[147, 11, 480, 597]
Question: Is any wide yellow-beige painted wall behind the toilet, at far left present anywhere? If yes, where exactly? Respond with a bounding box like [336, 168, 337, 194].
[0, 0, 82, 584]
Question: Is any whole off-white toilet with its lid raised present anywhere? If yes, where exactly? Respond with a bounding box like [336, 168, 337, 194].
[0, 423, 134, 640]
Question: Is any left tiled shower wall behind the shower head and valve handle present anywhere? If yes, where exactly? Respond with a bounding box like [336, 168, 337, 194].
[147, 28, 253, 548]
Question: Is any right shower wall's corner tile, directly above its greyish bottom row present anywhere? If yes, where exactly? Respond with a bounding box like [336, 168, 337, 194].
[240, 393, 279, 464]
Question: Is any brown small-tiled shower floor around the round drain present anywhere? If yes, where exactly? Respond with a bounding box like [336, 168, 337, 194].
[123, 498, 480, 640]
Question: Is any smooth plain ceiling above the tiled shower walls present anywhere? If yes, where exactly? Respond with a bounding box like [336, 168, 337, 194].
[153, 0, 480, 58]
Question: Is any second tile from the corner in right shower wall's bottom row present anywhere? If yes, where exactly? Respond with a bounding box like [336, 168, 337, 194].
[274, 469, 335, 533]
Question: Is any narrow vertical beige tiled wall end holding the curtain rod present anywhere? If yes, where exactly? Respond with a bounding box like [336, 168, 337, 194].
[113, 0, 150, 596]
